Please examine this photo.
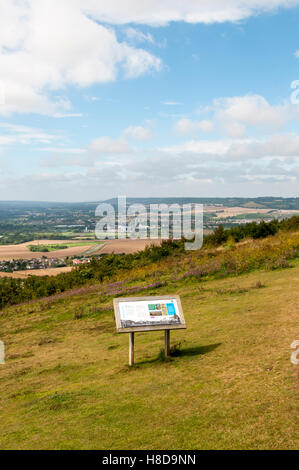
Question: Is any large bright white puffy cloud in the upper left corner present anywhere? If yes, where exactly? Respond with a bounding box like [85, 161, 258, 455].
[0, 0, 161, 117]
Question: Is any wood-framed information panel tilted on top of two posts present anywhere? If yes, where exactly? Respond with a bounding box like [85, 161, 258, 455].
[113, 295, 186, 333]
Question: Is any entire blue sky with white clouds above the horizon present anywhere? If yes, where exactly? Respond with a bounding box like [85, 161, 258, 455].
[0, 0, 299, 202]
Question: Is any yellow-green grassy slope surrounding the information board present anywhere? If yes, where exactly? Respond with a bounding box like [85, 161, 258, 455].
[0, 234, 299, 449]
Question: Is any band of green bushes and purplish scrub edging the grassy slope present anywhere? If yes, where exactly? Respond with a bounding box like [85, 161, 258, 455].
[0, 216, 299, 310]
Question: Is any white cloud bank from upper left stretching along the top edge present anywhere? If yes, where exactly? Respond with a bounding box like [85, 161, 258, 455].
[0, 0, 299, 117]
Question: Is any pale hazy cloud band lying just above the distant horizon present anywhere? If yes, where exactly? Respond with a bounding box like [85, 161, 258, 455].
[0, 135, 299, 200]
